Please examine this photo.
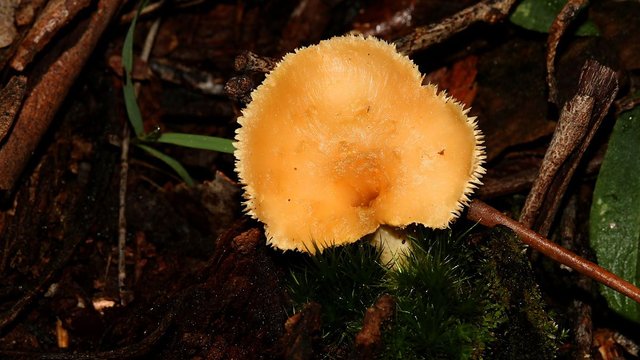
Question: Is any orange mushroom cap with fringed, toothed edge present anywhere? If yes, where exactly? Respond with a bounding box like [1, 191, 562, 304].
[235, 35, 485, 253]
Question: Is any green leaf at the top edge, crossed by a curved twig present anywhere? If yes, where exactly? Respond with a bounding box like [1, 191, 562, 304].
[509, 0, 600, 36]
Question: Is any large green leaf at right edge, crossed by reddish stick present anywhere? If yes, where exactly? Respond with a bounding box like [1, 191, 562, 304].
[589, 107, 640, 321]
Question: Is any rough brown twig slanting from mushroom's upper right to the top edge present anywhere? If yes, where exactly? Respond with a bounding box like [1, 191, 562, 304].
[394, 0, 515, 55]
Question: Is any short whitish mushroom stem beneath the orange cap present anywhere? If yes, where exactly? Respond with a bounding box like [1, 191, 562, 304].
[370, 225, 413, 268]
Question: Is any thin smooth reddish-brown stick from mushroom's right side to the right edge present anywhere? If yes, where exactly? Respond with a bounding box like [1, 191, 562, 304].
[467, 200, 640, 303]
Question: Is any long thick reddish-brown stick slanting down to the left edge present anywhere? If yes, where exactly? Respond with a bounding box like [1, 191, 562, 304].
[0, 0, 122, 192]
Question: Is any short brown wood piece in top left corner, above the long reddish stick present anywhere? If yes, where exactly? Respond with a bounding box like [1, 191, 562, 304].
[11, 0, 91, 71]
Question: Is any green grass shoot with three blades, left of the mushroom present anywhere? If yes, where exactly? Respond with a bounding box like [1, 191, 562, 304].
[122, 0, 234, 186]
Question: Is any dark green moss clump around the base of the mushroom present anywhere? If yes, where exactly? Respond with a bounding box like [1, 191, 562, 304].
[289, 227, 558, 359]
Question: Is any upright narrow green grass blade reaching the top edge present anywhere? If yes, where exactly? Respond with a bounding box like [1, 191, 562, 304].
[122, 0, 147, 137]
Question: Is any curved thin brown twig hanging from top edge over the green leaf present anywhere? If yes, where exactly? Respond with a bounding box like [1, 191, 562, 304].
[547, 0, 589, 104]
